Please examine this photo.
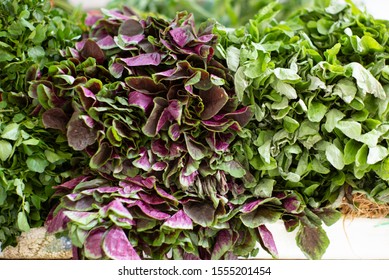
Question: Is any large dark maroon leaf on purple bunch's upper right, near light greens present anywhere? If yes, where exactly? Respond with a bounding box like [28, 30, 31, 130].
[199, 86, 228, 120]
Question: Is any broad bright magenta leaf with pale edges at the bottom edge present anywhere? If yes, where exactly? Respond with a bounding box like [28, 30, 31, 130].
[103, 226, 140, 260]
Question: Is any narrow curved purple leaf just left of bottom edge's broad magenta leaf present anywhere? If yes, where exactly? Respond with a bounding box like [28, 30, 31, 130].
[84, 227, 107, 260]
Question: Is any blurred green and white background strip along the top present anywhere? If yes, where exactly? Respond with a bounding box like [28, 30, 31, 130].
[68, 0, 389, 23]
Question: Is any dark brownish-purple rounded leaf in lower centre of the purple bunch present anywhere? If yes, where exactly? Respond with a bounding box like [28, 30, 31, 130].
[184, 201, 215, 227]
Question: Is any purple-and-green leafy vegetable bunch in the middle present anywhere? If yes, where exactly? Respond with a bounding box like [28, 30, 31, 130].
[29, 8, 300, 259]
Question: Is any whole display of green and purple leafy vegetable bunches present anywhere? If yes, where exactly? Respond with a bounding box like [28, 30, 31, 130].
[0, 0, 389, 260]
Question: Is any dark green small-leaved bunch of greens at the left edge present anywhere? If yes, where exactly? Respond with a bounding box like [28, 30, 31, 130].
[0, 0, 82, 247]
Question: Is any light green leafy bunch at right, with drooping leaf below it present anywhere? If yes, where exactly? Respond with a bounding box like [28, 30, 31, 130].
[217, 2, 389, 258]
